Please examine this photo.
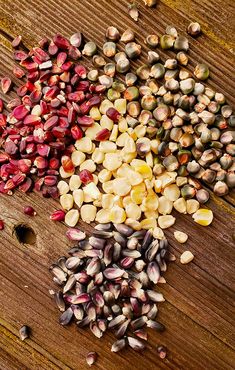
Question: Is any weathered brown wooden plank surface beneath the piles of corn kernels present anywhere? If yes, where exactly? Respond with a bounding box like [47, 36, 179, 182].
[0, 0, 235, 370]
